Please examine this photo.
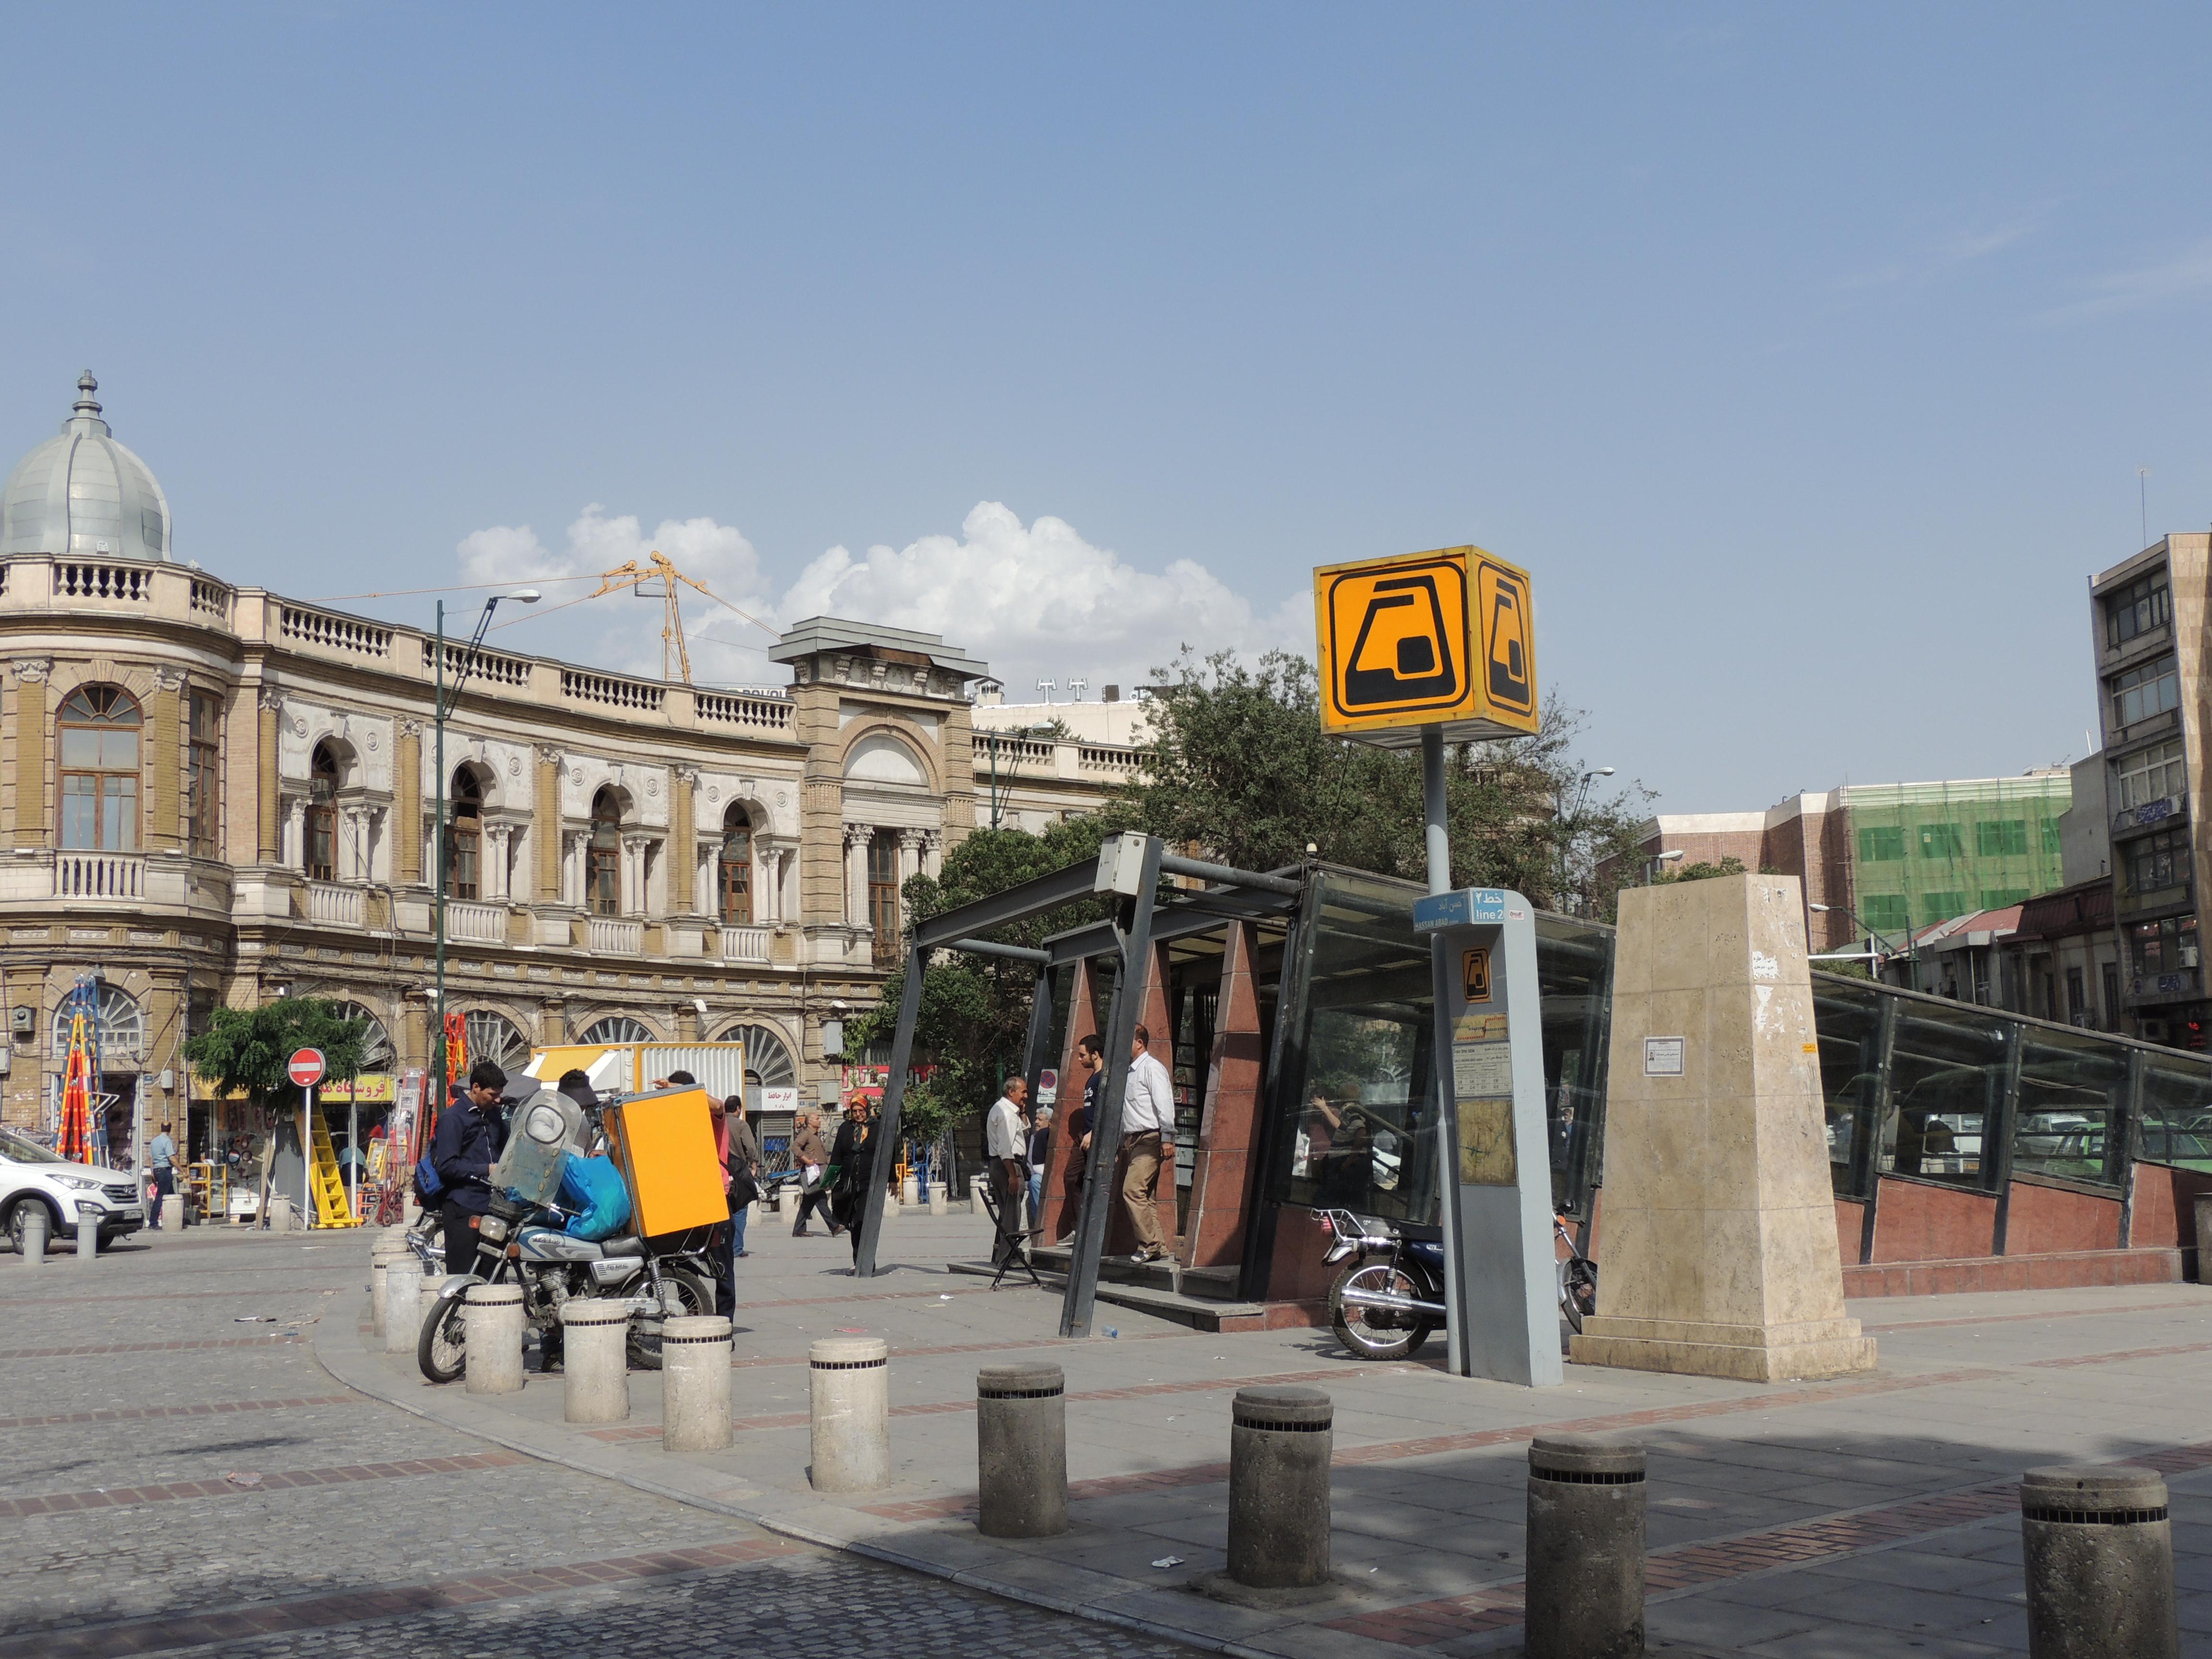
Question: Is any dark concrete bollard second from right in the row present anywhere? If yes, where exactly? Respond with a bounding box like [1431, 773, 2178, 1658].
[1527, 1433, 1644, 1659]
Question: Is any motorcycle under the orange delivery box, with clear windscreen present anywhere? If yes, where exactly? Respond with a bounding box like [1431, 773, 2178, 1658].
[407, 1091, 714, 1382]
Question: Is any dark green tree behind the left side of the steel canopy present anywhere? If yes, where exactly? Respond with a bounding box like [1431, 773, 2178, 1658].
[845, 816, 1113, 1142]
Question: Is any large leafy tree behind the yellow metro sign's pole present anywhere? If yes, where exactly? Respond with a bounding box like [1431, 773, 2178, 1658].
[1119, 650, 1646, 914]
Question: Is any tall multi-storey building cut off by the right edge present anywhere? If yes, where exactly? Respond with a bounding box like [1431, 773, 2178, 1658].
[2088, 533, 2212, 1048]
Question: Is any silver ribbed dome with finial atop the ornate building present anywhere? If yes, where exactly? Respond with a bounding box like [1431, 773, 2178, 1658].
[0, 370, 170, 560]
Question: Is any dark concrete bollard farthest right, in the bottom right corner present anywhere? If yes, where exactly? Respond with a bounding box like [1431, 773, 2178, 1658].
[2020, 1464, 2181, 1659]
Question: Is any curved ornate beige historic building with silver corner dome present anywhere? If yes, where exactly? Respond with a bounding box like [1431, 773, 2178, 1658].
[0, 374, 1110, 1157]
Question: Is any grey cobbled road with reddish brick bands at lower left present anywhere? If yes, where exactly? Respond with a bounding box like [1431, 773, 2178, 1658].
[0, 1230, 1188, 1659]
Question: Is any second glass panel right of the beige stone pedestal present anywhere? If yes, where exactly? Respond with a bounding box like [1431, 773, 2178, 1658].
[1875, 1002, 2015, 1188]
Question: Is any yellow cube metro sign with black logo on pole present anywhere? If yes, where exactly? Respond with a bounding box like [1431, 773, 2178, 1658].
[1314, 546, 1538, 743]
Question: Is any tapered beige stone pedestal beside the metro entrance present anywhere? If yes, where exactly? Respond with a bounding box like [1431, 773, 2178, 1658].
[1571, 876, 1874, 1382]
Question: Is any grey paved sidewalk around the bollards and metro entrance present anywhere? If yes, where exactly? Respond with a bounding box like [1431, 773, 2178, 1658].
[316, 1214, 2212, 1659]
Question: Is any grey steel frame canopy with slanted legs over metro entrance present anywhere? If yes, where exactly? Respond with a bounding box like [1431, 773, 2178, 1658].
[854, 832, 1305, 1336]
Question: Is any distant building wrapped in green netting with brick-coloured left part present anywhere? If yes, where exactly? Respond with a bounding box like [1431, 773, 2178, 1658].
[1639, 768, 2073, 953]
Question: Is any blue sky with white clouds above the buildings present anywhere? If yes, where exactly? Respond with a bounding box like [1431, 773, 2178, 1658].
[0, 4, 2212, 812]
